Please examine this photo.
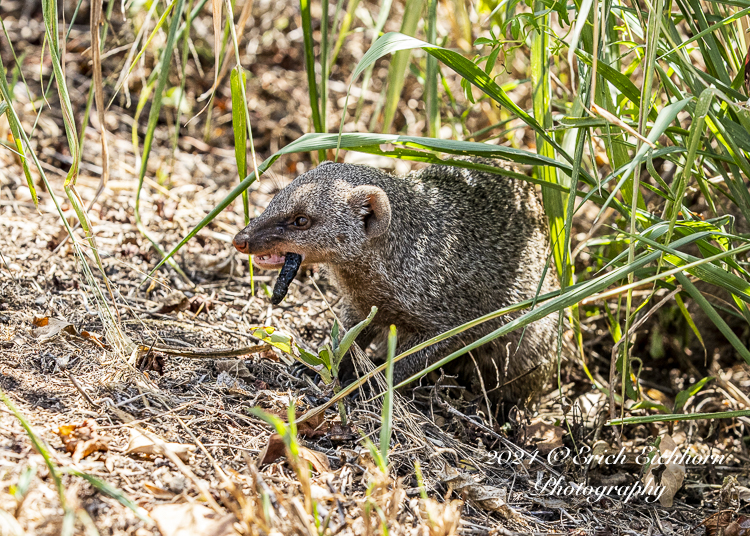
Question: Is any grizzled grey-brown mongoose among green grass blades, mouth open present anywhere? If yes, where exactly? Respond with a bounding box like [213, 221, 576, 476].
[234, 160, 557, 402]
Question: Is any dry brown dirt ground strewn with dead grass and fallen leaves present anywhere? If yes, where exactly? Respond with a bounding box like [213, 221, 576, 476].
[0, 0, 750, 536]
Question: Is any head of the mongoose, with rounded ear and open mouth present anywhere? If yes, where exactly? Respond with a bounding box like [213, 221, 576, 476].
[234, 163, 391, 270]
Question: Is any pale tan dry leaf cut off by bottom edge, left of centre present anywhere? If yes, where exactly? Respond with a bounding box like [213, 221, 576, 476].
[149, 504, 237, 536]
